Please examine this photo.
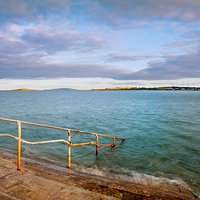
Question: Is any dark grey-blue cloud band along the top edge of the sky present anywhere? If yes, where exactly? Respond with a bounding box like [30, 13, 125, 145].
[0, 0, 200, 26]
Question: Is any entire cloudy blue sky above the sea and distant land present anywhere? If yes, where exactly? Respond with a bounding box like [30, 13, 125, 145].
[0, 0, 200, 90]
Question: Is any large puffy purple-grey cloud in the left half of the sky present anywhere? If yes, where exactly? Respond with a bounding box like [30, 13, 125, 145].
[0, 20, 109, 68]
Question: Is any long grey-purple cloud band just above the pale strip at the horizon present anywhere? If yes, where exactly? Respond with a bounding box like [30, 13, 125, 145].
[0, 51, 200, 80]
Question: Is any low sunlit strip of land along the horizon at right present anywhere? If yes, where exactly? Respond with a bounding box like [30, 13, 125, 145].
[92, 86, 200, 91]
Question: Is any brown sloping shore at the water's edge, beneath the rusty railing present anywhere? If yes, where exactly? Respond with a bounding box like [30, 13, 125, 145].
[0, 152, 198, 200]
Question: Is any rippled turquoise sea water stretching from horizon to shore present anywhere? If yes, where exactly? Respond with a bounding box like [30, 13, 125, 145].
[0, 90, 200, 193]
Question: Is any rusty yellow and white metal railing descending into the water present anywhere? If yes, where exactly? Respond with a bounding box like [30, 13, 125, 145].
[0, 118, 125, 170]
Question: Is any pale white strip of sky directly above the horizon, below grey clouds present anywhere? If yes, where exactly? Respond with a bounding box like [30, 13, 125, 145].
[0, 78, 200, 90]
